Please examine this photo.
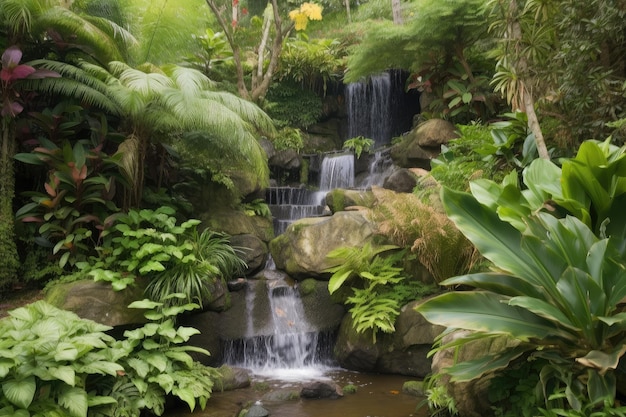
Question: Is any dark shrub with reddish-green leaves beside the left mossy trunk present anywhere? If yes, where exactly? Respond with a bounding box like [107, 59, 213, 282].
[15, 131, 123, 267]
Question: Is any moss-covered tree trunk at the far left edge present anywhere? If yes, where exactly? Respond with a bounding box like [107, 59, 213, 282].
[0, 117, 20, 288]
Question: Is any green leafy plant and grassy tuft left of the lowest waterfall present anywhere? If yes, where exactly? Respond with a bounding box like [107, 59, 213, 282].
[77, 207, 245, 305]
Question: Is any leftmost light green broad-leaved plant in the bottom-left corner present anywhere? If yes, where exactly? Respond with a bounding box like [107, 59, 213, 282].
[0, 301, 124, 417]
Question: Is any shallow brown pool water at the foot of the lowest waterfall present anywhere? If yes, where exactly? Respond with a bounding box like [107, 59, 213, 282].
[165, 371, 428, 417]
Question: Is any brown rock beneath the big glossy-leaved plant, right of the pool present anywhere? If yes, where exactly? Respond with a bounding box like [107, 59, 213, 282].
[432, 330, 520, 417]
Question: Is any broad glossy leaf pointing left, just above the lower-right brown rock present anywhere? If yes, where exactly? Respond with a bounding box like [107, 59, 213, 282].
[416, 291, 570, 340]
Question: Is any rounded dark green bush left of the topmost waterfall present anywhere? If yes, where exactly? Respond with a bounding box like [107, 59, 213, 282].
[263, 81, 323, 129]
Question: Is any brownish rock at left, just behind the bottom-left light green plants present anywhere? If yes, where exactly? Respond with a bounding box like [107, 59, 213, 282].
[46, 279, 147, 327]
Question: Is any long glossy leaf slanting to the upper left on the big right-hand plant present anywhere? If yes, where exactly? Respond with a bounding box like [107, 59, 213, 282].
[442, 188, 542, 285]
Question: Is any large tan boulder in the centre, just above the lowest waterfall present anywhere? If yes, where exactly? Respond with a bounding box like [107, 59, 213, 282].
[270, 211, 375, 279]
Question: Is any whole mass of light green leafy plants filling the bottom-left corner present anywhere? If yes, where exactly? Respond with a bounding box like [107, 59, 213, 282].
[0, 295, 218, 417]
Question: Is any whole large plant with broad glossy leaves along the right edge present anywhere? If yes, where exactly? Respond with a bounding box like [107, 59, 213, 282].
[417, 141, 626, 411]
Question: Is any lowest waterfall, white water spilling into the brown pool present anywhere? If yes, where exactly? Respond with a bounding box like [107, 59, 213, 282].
[225, 271, 331, 380]
